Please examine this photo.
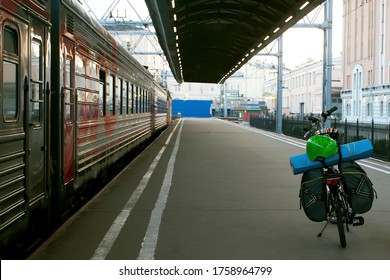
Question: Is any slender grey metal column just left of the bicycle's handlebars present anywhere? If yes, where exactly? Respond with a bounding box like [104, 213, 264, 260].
[275, 36, 283, 134]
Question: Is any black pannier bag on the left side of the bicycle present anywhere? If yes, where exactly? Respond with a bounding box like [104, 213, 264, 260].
[299, 168, 326, 222]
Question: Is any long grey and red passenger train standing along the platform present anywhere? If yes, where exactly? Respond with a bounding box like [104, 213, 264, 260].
[0, 0, 172, 259]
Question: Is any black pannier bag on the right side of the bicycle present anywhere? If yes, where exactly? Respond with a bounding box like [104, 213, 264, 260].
[340, 161, 376, 214]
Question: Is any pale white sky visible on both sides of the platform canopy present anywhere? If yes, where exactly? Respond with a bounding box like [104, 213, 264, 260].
[83, 0, 343, 69]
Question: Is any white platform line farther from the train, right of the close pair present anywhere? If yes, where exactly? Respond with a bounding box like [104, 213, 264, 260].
[138, 118, 183, 260]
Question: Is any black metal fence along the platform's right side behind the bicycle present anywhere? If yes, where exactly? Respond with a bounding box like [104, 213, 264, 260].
[250, 117, 390, 161]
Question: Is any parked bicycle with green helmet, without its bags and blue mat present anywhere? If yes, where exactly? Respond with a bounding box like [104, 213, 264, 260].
[304, 107, 364, 248]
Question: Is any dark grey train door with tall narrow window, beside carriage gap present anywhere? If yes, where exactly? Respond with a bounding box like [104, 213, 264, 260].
[24, 17, 50, 238]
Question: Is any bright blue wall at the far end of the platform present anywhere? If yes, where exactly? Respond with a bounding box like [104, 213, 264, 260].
[172, 99, 213, 118]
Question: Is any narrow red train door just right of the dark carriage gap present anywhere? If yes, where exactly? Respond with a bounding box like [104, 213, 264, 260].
[63, 38, 75, 184]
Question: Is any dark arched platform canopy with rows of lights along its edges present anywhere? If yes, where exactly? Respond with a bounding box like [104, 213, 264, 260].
[145, 0, 324, 83]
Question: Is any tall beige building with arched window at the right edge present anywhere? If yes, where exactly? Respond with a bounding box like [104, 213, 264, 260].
[341, 0, 390, 124]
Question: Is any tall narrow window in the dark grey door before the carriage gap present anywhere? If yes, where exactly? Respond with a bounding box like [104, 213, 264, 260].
[30, 40, 43, 125]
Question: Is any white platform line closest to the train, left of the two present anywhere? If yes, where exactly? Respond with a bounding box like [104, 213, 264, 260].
[91, 120, 181, 260]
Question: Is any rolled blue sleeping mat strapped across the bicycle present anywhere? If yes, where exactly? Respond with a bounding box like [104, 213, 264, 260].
[290, 139, 374, 175]
